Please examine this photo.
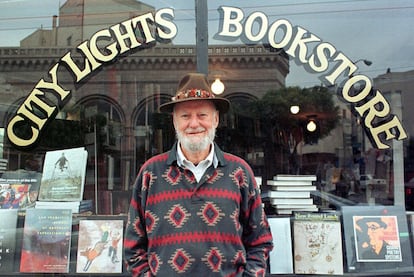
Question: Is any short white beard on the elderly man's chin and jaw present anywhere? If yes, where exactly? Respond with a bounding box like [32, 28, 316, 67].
[176, 128, 216, 152]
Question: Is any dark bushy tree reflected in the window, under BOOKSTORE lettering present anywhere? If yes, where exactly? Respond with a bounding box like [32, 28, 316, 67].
[250, 86, 340, 178]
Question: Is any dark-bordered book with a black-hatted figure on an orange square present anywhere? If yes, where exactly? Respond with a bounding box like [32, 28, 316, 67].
[342, 206, 413, 272]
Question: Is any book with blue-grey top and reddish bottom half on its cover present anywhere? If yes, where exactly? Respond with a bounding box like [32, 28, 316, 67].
[20, 209, 72, 273]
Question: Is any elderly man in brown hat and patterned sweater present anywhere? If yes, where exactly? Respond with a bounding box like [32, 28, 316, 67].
[124, 73, 273, 276]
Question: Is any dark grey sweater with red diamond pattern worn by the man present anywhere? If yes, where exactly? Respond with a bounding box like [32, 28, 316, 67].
[124, 144, 273, 277]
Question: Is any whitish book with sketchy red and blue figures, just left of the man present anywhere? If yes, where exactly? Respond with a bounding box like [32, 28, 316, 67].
[76, 219, 124, 273]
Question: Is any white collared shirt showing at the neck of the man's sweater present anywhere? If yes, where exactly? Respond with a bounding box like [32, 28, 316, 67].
[177, 143, 218, 182]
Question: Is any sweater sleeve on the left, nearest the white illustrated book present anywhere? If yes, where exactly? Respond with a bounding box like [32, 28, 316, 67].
[124, 173, 151, 277]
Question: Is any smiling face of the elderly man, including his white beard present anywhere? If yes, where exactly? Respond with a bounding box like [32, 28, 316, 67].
[173, 100, 219, 152]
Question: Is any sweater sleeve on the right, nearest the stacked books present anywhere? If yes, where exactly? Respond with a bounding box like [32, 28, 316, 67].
[242, 171, 273, 276]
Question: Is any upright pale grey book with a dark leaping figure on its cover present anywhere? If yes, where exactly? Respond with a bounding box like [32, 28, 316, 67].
[38, 147, 88, 201]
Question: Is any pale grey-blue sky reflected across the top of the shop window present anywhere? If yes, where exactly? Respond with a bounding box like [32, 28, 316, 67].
[0, 0, 414, 87]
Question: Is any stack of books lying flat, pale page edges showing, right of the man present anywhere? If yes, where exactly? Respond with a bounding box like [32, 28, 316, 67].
[262, 175, 318, 214]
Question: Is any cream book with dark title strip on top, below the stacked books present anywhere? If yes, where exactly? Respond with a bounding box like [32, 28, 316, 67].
[293, 212, 343, 275]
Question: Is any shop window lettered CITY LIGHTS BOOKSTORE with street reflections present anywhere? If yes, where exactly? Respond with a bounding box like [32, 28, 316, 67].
[0, 0, 414, 276]
